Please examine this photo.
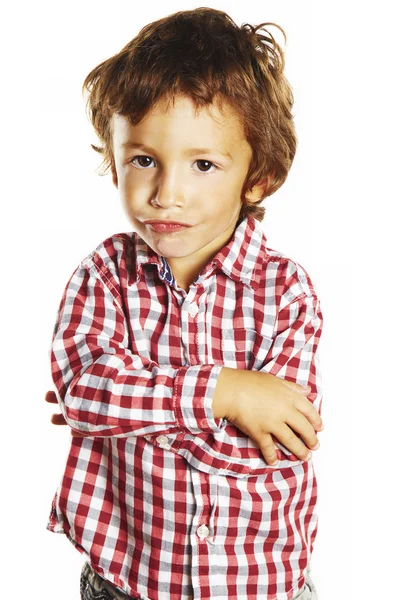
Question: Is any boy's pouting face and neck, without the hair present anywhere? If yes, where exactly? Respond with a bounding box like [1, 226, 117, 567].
[112, 96, 265, 290]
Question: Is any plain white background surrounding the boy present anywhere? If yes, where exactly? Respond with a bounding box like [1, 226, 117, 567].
[0, 0, 400, 600]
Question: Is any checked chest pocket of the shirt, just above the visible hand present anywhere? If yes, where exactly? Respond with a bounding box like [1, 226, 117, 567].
[221, 328, 272, 371]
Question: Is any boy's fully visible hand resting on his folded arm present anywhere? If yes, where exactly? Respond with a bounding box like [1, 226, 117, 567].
[226, 370, 323, 465]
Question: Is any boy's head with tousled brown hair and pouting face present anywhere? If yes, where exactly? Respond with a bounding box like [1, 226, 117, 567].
[83, 8, 297, 282]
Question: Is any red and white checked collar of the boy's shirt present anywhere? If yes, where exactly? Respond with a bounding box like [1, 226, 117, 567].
[133, 216, 267, 289]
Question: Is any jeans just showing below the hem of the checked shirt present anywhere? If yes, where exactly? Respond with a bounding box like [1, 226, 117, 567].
[80, 562, 318, 600]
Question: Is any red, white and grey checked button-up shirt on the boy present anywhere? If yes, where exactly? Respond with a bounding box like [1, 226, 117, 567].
[47, 217, 322, 600]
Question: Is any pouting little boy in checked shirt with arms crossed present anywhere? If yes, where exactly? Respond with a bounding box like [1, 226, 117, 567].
[48, 8, 322, 600]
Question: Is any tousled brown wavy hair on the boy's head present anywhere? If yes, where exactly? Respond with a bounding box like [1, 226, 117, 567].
[82, 7, 297, 221]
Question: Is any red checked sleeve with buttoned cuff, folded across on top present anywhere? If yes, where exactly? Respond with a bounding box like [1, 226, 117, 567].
[50, 259, 227, 437]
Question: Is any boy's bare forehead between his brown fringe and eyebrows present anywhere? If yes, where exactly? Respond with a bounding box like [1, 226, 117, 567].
[112, 96, 244, 145]
